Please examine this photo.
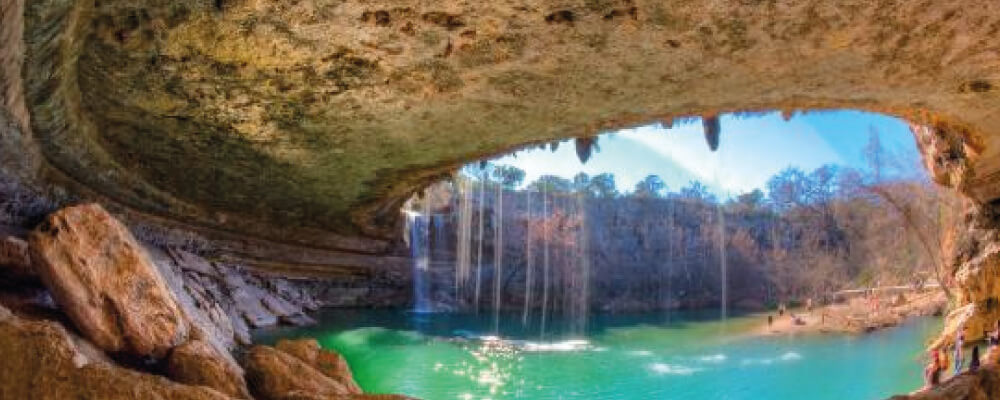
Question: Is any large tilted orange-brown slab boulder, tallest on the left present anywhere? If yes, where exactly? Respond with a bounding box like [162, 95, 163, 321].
[28, 204, 189, 358]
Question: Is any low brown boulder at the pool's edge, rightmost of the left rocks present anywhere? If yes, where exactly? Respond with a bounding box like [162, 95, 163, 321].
[243, 346, 355, 400]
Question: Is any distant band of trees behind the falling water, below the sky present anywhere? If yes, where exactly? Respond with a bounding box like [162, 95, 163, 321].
[422, 136, 959, 311]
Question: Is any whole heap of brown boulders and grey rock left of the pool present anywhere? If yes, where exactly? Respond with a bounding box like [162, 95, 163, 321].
[0, 204, 414, 400]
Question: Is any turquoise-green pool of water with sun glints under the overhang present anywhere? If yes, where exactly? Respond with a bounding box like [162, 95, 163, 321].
[257, 310, 941, 400]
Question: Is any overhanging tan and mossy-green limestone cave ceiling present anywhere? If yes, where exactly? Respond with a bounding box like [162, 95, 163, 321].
[3, 0, 1000, 253]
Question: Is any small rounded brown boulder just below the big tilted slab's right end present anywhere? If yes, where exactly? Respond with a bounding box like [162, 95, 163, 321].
[167, 340, 251, 399]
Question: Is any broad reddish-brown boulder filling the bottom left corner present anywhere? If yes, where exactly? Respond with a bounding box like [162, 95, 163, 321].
[0, 307, 229, 400]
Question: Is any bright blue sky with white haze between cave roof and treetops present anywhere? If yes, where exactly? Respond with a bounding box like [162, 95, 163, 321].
[493, 110, 923, 198]
